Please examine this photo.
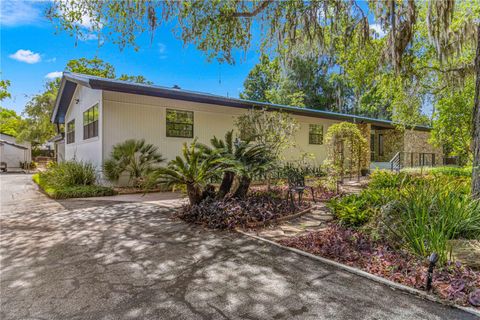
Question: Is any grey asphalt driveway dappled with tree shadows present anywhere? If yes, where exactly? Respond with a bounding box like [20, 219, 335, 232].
[0, 175, 474, 319]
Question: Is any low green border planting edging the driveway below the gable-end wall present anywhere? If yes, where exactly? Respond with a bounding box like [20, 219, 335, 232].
[32, 173, 116, 199]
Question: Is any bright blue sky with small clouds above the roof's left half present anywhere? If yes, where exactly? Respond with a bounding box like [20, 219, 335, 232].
[0, 0, 259, 113]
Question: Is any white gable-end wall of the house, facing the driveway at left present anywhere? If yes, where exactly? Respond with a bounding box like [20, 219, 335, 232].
[65, 86, 103, 170]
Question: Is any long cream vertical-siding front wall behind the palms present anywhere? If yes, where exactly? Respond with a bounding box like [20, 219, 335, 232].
[101, 91, 337, 163]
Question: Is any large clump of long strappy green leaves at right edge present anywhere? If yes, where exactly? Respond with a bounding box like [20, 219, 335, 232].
[387, 179, 480, 263]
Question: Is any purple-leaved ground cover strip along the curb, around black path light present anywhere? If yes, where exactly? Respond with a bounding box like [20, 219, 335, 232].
[280, 224, 480, 309]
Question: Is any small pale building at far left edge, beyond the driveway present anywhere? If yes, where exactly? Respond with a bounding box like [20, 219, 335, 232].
[0, 133, 32, 171]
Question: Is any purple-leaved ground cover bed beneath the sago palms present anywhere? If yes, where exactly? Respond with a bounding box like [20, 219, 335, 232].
[178, 193, 309, 229]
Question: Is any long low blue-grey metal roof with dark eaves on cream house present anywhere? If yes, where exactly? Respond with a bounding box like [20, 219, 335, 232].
[51, 72, 431, 131]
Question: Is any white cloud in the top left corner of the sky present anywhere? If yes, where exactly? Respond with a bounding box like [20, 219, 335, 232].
[0, 0, 42, 27]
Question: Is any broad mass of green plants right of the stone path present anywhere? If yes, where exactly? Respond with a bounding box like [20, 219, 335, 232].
[329, 167, 480, 263]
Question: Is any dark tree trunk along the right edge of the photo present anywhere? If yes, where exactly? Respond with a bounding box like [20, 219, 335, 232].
[472, 24, 480, 199]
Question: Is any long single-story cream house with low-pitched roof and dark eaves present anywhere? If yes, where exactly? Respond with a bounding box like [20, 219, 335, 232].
[51, 72, 442, 176]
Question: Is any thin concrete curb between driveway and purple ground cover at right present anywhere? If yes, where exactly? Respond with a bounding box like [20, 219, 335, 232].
[236, 229, 480, 318]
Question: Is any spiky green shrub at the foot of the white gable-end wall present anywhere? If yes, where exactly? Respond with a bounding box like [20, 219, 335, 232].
[41, 161, 97, 187]
